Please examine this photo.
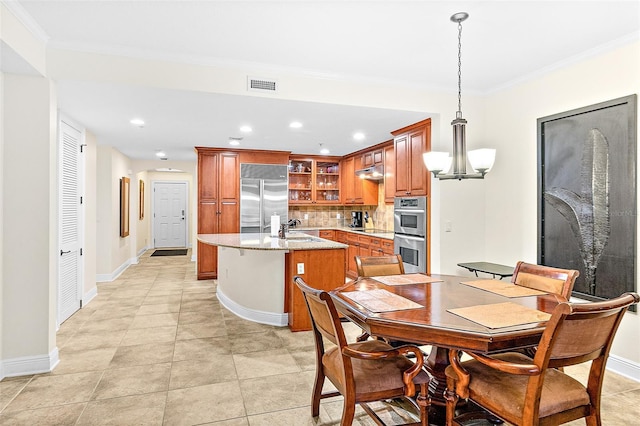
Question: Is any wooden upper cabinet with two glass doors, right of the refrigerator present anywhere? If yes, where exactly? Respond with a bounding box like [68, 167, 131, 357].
[289, 156, 340, 204]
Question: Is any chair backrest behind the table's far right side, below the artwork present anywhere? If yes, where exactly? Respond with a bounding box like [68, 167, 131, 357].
[511, 261, 580, 300]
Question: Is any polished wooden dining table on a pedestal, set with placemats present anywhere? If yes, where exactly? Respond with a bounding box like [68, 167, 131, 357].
[330, 274, 566, 418]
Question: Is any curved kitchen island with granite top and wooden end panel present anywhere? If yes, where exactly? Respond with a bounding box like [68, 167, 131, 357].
[198, 233, 348, 331]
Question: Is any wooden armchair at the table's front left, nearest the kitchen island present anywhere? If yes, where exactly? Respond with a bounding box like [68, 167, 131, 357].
[294, 276, 430, 426]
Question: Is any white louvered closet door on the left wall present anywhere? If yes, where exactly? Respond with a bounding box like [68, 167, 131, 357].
[58, 121, 82, 324]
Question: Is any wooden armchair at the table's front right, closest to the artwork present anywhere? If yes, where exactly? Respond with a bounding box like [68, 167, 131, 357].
[445, 293, 640, 426]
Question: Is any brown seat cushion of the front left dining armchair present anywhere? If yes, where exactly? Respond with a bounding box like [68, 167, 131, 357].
[322, 340, 429, 400]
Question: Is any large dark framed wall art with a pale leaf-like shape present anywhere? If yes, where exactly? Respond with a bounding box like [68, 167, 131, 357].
[538, 95, 637, 300]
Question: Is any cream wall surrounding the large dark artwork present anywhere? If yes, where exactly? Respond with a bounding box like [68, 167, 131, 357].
[484, 42, 640, 372]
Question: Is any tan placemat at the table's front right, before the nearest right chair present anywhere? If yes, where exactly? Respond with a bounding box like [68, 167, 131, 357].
[447, 302, 551, 328]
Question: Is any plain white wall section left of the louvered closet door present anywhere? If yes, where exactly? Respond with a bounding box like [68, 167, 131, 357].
[2, 74, 58, 374]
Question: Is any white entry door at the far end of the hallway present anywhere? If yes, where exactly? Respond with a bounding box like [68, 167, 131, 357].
[152, 182, 187, 248]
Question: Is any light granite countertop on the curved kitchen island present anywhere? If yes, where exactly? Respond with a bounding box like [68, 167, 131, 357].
[198, 232, 349, 250]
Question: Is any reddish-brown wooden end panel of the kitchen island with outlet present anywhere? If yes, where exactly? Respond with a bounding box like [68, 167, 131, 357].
[284, 248, 346, 331]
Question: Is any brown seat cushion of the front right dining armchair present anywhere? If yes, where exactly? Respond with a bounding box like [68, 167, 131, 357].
[445, 353, 589, 420]
